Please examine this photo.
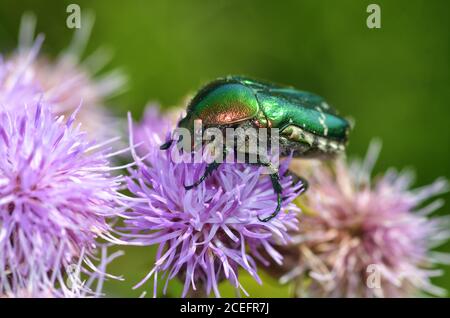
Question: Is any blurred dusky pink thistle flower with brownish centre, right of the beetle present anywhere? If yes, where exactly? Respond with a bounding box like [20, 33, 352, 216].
[282, 143, 450, 297]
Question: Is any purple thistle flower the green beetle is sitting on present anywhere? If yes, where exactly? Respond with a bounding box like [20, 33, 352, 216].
[124, 110, 302, 297]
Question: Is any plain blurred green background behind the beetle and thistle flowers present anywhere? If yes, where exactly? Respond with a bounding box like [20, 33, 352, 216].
[0, 0, 450, 297]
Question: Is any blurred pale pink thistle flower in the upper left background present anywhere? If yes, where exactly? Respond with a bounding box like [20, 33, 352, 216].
[0, 14, 127, 140]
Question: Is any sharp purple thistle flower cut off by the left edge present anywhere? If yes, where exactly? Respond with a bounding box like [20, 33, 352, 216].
[0, 103, 121, 294]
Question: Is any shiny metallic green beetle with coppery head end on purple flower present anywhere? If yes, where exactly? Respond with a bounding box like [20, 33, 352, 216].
[161, 76, 350, 222]
